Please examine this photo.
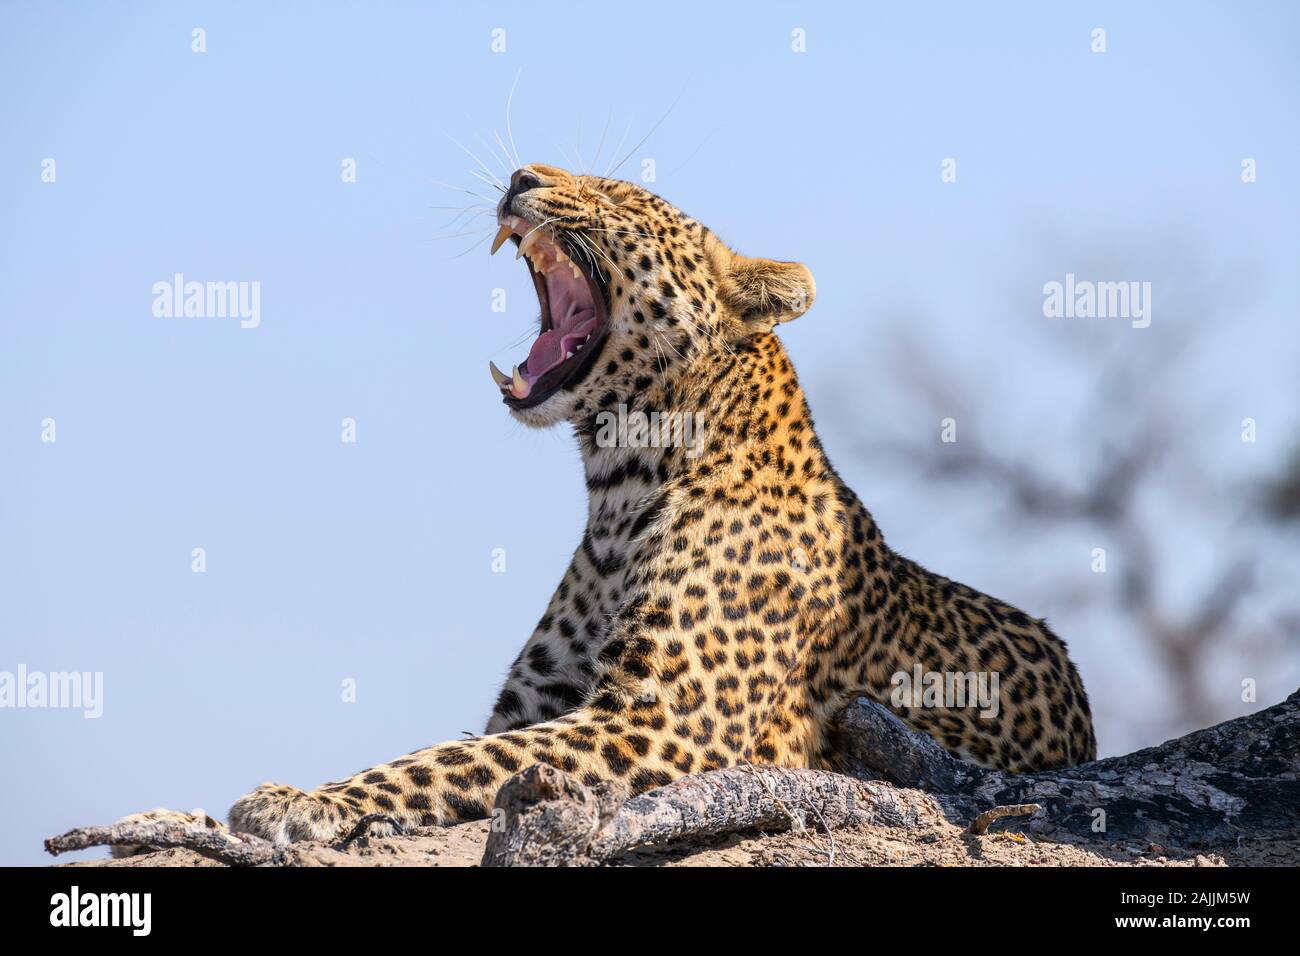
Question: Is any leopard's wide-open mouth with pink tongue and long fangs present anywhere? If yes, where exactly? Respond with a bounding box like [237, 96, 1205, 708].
[489, 216, 610, 408]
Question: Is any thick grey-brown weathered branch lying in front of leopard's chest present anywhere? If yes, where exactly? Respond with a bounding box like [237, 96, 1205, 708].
[482, 763, 943, 866]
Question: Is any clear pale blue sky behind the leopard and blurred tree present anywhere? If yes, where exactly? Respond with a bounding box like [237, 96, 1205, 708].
[0, 3, 1300, 864]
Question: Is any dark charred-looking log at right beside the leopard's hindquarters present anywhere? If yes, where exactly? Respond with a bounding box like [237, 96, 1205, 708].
[837, 691, 1300, 847]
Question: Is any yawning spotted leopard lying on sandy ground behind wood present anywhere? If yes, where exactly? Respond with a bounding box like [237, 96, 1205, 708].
[114, 164, 1096, 843]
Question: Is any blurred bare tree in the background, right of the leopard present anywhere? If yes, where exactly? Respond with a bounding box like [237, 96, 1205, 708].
[835, 254, 1300, 732]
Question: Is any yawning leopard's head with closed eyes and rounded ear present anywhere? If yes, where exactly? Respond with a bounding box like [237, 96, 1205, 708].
[491, 165, 815, 427]
